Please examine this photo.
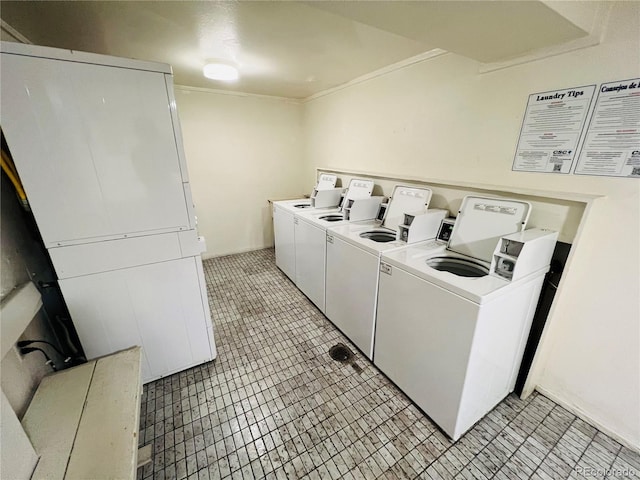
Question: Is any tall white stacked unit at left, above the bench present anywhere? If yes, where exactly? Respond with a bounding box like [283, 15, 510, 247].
[0, 42, 216, 382]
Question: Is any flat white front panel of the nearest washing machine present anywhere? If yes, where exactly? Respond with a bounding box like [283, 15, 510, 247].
[373, 267, 478, 437]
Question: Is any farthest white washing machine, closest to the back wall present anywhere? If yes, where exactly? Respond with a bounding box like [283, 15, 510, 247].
[272, 173, 342, 282]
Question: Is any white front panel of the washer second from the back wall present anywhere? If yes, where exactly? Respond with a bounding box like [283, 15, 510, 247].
[294, 219, 327, 313]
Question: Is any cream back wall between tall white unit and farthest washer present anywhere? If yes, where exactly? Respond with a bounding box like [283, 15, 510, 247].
[175, 86, 303, 257]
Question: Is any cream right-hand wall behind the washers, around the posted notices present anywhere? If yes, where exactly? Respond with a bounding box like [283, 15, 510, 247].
[304, 2, 640, 446]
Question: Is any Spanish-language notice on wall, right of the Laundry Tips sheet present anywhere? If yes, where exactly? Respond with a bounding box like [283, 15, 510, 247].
[575, 78, 640, 178]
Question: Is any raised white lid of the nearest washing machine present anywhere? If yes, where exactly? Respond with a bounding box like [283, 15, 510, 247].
[448, 196, 531, 262]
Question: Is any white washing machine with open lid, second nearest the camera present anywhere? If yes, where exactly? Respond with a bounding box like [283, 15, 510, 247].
[325, 185, 446, 359]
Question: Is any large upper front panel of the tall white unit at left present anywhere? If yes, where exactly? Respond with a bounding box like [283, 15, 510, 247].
[1, 53, 189, 247]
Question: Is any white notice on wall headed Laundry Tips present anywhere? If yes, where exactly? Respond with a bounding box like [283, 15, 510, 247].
[513, 85, 596, 174]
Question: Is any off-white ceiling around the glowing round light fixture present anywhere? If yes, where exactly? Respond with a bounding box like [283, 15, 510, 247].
[0, 0, 589, 98]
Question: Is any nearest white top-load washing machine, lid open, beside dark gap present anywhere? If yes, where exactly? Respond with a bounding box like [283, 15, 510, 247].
[373, 197, 557, 440]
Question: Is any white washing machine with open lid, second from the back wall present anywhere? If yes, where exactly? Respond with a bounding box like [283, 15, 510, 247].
[294, 179, 384, 313]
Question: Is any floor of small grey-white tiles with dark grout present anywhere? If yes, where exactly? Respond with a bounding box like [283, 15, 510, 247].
[138, 249, 640, 480]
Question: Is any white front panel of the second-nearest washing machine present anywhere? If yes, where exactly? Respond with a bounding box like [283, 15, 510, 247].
[325, 232, 378, 358]
